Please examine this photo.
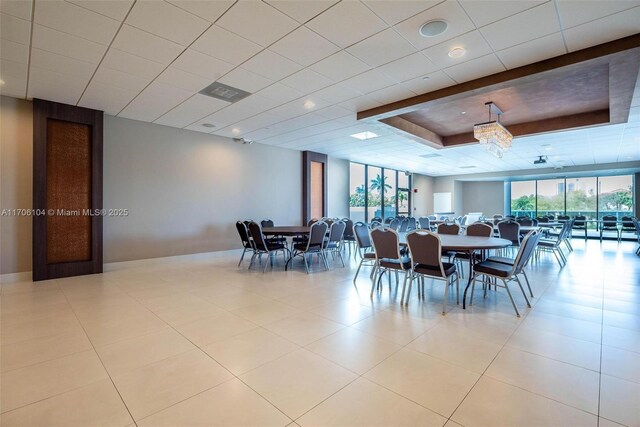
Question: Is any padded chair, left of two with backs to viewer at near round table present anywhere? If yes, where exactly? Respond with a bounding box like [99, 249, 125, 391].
[370, 227, 411, 297]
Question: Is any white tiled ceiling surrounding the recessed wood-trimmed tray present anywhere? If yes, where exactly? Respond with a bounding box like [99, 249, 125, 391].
[0, 0, 640, 176]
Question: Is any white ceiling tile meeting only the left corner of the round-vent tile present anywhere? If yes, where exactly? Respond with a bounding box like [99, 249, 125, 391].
[306, 1, 387, 48]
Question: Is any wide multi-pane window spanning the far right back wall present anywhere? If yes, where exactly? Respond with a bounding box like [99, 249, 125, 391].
[511, 175, 633, 224]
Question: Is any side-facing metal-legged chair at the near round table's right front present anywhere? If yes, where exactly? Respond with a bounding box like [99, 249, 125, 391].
[469, 234, 535, 317]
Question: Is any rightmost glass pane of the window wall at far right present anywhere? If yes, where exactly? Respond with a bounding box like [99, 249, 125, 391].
[598, 175, 633, 219]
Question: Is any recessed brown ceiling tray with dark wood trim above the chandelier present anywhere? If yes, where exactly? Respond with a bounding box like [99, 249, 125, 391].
[358, 34, 640, 149]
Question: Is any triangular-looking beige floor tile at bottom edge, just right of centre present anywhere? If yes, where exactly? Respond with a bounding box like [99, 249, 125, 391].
[297, 378, 447, 427]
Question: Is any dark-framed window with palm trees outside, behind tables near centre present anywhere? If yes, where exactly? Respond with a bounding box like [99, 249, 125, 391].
[349, 163, 411, 222]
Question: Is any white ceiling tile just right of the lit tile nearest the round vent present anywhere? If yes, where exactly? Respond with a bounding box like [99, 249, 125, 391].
[480, 2, 560, 50]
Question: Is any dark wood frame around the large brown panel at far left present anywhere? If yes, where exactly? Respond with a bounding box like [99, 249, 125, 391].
[32, 98, 103, 281]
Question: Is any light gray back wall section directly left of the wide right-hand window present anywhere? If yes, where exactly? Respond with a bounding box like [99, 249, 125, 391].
[461, 181, 504, 217]
